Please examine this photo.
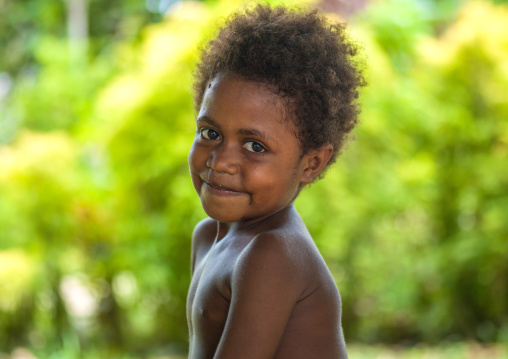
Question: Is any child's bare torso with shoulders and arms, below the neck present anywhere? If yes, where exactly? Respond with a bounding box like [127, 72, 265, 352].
[187, 206, 347, 359]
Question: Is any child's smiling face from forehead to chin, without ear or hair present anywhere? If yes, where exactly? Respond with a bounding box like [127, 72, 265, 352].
[189, 75, 305, 222]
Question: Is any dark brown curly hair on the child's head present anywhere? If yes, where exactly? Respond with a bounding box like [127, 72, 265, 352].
[194, 5, 365, 170]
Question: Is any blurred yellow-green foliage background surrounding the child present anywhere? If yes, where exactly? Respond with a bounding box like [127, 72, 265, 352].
[0, 0, 508, 359]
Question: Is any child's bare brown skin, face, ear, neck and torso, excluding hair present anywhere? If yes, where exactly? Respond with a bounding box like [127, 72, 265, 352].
[187, 74, 347, 359]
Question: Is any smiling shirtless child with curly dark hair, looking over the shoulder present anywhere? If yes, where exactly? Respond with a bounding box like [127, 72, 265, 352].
[187, 6, 363, 359]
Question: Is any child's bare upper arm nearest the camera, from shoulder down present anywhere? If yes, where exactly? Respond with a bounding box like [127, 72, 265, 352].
[214, 235, 306, 359]
